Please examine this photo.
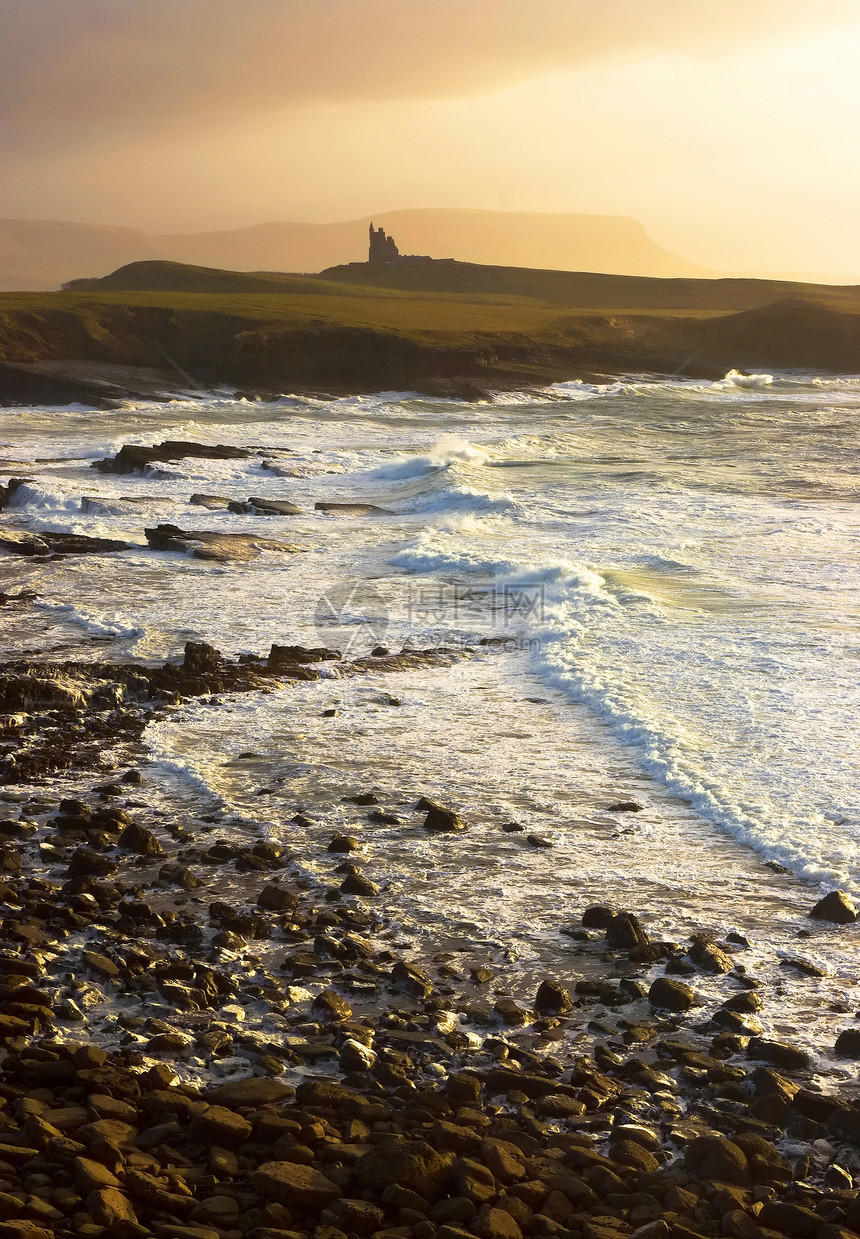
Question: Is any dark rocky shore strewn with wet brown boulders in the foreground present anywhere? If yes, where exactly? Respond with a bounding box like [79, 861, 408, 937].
[0, 629, 860, 1239]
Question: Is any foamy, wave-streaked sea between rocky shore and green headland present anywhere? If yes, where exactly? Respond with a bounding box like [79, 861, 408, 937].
[0, 372, 860, 1070]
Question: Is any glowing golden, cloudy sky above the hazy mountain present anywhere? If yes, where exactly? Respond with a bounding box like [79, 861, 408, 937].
[0, 0, 860, 275]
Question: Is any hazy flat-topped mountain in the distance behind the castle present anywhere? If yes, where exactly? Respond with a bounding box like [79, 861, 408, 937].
[0, 208, 719, 290]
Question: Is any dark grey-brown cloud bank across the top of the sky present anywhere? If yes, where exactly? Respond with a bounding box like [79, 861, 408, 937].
[0, 0, 855, 159]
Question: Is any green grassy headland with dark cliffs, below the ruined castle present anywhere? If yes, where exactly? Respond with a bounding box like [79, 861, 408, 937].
[0, 261, 860, 396]
